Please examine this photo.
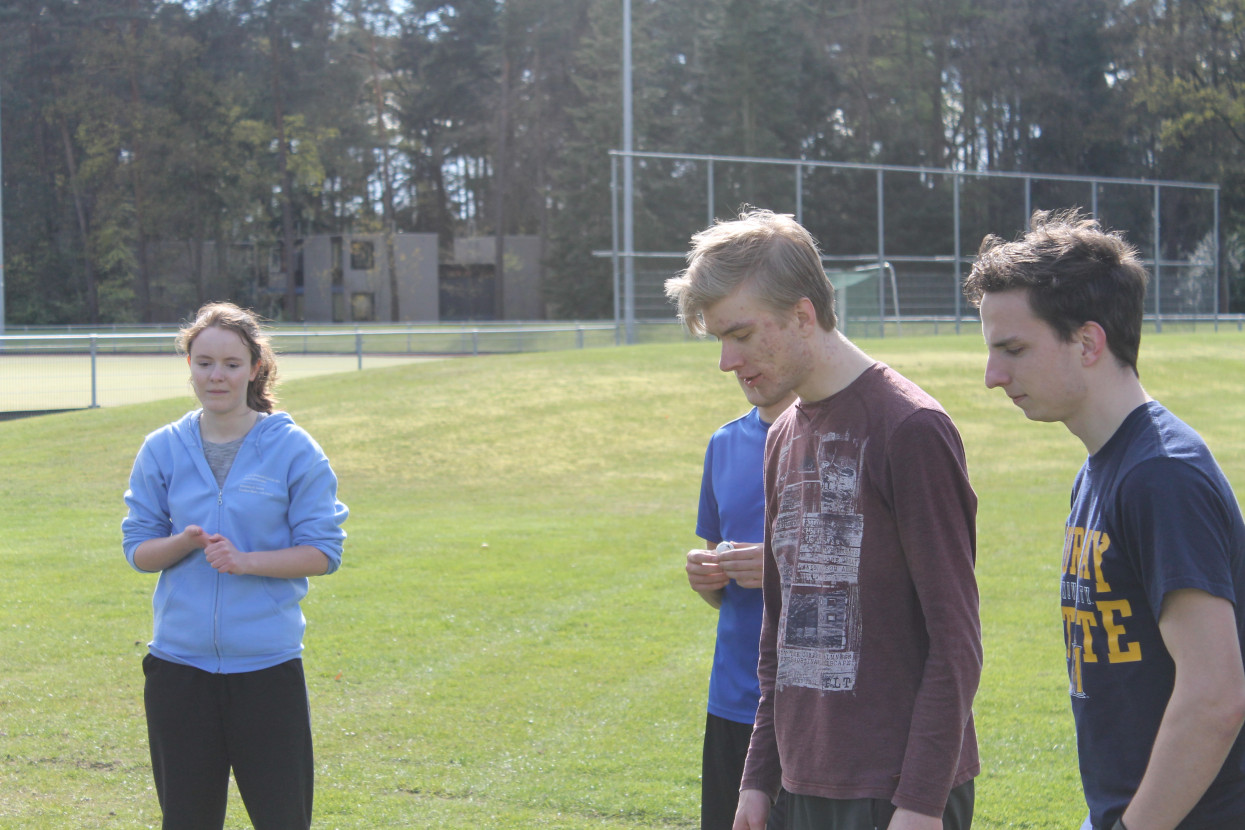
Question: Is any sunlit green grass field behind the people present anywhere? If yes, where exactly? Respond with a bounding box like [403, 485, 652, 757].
[0, 332, 1245, 830]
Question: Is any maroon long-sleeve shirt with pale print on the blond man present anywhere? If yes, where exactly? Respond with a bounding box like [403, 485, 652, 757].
[742, 363, 982, 815]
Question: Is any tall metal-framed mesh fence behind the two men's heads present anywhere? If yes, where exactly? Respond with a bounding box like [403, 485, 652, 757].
[610, 151, 1228, 335]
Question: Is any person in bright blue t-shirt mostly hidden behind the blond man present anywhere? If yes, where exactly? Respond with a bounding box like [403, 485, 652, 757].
[686, 381, 796, 830]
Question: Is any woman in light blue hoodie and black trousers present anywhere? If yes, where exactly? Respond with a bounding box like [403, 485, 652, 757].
[122, 302, 347, 830]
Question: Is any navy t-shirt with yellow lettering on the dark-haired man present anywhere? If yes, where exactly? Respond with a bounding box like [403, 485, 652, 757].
[1061, 402, 1245, 829]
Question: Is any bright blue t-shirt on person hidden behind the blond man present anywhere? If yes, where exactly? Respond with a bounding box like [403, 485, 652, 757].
[696, 408, 769, 723]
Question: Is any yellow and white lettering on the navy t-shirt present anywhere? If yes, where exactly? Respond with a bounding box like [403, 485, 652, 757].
[1059, 525, 1142, 698]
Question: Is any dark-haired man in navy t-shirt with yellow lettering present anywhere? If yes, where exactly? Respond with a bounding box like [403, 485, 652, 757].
[965, 212, 1245, 830]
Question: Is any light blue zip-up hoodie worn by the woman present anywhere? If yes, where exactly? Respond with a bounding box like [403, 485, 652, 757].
[121, 409, 347, 674]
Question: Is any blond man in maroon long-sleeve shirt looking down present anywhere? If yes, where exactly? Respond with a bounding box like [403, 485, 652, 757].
[666, 210, 981, 830]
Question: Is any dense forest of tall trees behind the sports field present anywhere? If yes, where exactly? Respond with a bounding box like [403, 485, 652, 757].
[0, 0, 1245, 324]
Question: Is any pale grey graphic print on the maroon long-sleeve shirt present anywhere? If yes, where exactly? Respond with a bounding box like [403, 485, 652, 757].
[772, 433, 868, 692]
